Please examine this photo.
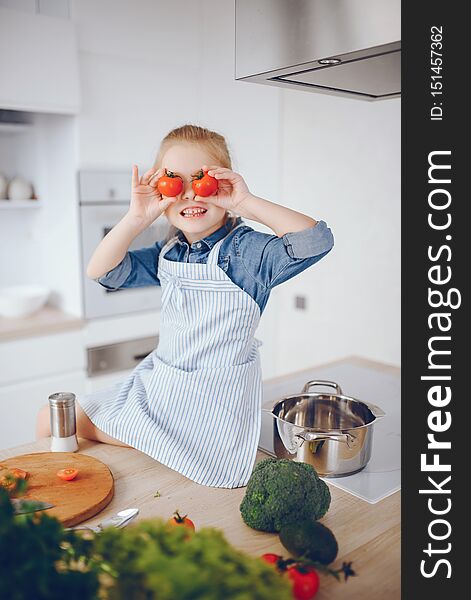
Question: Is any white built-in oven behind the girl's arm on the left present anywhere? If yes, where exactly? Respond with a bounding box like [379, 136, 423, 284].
[79, 170, 169, 319]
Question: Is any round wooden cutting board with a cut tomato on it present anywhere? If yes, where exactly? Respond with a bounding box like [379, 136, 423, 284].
[0, 452, 114, 527]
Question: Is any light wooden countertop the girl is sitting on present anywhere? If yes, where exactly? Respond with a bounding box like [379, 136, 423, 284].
[0, 358, 400, 600]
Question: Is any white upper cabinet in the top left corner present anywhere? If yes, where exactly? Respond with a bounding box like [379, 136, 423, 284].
[0, 7, 80, 114]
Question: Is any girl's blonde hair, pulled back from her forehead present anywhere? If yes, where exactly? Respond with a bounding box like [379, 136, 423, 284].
[154, 125, 237, 240]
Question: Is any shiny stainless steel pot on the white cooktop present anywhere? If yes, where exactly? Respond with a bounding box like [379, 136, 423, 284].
[262, 380, 385, 477]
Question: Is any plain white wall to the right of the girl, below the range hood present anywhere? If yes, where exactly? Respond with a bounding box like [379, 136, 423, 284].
[278, 90, 401, 373]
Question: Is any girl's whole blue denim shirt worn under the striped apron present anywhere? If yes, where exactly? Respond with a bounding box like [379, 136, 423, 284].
[95, 217, 334, 312]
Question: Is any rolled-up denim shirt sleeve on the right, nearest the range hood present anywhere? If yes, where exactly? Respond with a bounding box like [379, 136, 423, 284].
[234, 221, 334, 290]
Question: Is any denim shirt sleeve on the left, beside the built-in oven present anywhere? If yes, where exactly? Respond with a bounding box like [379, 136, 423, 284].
[95, 241, 164, 290]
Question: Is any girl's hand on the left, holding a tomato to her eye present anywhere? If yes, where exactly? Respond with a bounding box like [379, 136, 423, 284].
[128, 165, 176, 227]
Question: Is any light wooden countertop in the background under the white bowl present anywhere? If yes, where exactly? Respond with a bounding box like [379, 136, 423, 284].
[0, 306, 85, 342]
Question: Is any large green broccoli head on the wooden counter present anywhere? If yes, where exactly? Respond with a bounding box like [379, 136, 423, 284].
[240, 458, 330, 533]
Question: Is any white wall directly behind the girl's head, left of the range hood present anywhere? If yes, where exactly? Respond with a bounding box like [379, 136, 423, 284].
[71, 0, 281, 377]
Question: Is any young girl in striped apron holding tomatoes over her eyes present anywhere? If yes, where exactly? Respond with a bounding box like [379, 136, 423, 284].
[38, 125, 333, 488]
